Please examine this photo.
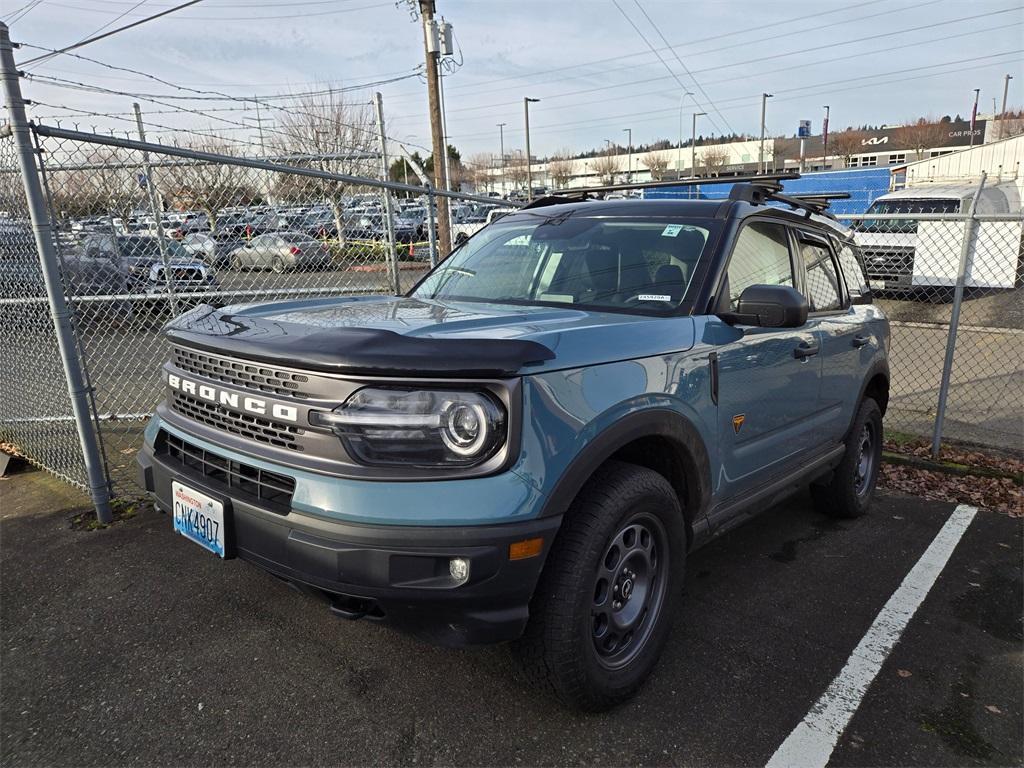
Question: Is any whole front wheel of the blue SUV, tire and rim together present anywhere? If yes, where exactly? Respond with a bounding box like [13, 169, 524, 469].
[517, 462, 686, 712]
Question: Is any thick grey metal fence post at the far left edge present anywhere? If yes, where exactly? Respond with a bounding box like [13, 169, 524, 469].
[0, 23, 113, 523]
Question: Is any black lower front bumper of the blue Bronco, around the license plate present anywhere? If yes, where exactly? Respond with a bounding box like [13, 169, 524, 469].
[137, 436, 561, 646]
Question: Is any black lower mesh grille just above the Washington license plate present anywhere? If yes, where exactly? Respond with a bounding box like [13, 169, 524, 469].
[157, 429, 295, 514]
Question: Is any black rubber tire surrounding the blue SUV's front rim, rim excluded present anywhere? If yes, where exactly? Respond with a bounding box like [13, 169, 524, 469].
[514, 462, 686, 712]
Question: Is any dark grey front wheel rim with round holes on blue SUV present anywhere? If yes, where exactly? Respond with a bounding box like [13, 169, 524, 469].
[591, 514, 669, 669]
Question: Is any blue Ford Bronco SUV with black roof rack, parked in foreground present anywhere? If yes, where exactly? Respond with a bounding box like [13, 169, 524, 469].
[138, 179, 889, 710]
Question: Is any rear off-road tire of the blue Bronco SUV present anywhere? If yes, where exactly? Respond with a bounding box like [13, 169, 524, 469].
[811, 397, 882, 518]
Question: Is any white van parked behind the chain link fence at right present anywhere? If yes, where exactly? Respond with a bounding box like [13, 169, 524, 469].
[852, 182, 1022, 292]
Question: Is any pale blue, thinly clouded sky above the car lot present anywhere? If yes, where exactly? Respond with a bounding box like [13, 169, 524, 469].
[8, 0, 1024, 158]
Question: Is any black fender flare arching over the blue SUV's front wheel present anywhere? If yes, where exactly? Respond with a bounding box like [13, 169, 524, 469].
[541, 408, 712, 527]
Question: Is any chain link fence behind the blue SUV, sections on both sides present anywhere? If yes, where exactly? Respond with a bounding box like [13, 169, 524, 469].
[0, 114, 1024, 505]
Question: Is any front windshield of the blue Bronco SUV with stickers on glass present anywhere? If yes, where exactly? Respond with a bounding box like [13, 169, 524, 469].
[413, 212, 714, 313]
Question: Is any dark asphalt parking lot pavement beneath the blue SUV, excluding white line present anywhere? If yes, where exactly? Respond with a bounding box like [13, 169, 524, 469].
[0, 472, 1024, 766]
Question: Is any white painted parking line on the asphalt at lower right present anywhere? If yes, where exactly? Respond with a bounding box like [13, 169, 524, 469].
[768, 504, 978, 768]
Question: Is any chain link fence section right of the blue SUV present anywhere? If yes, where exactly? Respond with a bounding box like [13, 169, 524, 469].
[840, 200, 1024, 452]
